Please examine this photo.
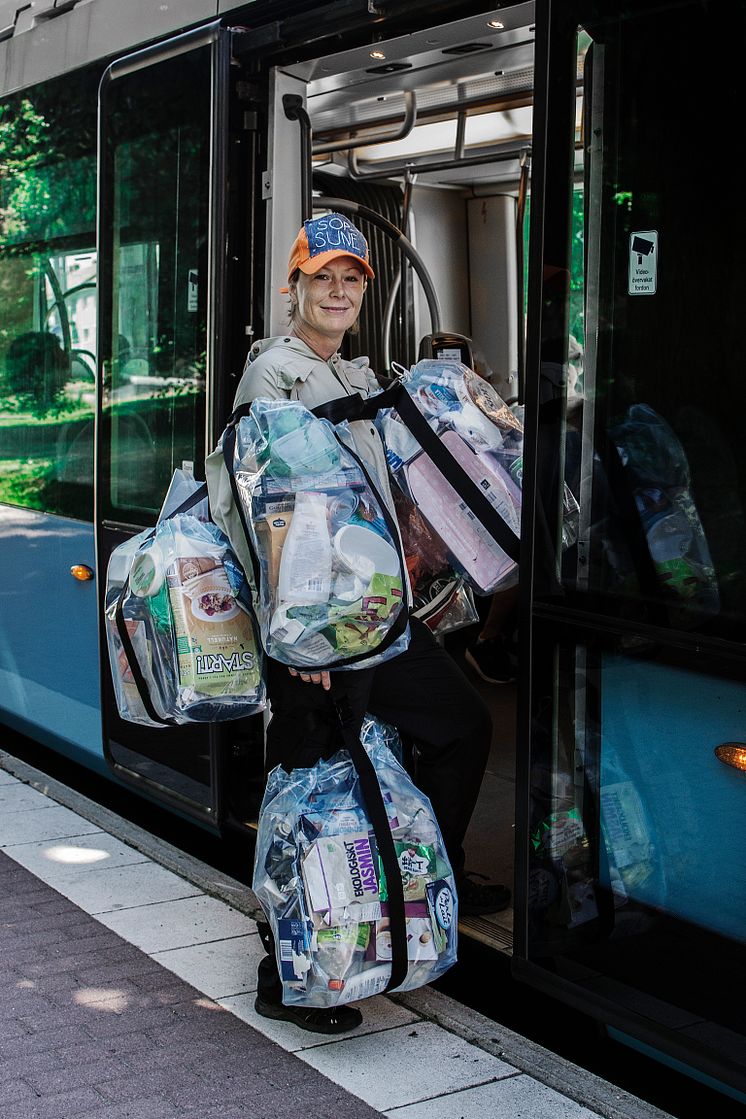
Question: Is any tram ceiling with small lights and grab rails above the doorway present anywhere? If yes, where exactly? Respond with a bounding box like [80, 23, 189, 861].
[299, 4, 533, 184]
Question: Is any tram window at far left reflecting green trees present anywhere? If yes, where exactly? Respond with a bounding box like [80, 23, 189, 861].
[0, 74, 96, 520]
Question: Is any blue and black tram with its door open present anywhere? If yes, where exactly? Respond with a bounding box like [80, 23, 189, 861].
[0, 0, 746, 1101]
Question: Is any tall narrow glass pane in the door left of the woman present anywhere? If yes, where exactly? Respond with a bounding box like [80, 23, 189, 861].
[102, 53, 210, 523]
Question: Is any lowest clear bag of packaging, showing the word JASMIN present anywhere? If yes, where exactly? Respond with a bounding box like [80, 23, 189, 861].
[253, 716, 457, 1007]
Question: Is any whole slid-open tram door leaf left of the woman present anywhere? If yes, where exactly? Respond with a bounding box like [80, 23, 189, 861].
[97, 28, 227, 818]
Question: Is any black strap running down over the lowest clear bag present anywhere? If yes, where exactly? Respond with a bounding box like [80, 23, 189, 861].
[334, 696, 409, 990]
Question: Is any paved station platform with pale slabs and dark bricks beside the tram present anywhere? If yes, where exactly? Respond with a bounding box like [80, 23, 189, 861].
[0, 751, 670, 1119]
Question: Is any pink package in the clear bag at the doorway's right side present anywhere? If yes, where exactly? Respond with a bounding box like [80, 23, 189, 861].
[404, 431, 521, 594]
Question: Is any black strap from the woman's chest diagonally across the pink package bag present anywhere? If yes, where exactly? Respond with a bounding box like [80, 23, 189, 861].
[313, 382, 520, 563]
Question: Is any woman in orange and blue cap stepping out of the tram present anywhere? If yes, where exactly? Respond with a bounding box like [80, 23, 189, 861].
[207, 214, 510, 1034]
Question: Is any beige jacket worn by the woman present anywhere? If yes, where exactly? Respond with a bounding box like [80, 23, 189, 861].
[205, 337, 396, 584]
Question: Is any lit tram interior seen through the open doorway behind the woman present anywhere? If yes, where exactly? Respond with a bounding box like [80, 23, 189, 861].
[259, 3, 545, 951]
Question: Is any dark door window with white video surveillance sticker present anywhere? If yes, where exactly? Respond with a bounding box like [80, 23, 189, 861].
[542, 6, 746, 641]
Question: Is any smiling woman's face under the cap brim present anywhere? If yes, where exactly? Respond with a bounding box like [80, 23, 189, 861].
[290, 256, 367, 341]
